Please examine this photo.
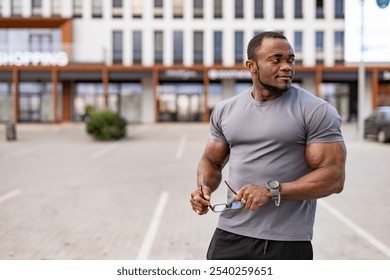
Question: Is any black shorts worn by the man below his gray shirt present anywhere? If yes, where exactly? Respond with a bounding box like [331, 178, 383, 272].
[207, 228, 313, 260]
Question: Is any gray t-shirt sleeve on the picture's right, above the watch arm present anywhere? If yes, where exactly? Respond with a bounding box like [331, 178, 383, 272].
[306, 102, 344, 144]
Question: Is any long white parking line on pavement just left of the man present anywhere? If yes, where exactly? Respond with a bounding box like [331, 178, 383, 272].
[137, 191, 169, 260]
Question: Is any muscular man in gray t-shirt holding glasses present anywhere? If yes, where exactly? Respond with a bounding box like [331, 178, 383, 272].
[191, 32, 346, 259]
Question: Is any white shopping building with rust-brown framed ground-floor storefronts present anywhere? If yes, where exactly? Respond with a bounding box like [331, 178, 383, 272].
[0, 0, 390, 123]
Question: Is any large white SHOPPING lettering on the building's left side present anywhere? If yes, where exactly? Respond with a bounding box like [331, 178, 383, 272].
[0, 52, 69, 66]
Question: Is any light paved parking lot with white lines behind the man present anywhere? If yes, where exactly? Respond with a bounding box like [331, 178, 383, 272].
[0, 124, 390, 260]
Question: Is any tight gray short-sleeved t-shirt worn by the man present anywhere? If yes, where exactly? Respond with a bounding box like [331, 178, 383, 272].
[210, 86, 343, 241]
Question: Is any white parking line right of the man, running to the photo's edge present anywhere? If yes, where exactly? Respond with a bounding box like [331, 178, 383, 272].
[318, 200, 390, 258]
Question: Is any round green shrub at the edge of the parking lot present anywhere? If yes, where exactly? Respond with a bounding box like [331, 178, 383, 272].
[87, 110, 126, 140]
